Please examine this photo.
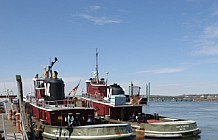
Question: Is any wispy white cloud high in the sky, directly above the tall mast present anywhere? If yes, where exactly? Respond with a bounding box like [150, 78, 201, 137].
[75, 14, 123, 25]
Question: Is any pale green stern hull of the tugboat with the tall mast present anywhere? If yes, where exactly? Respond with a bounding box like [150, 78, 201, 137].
[132, 121, 201, 138]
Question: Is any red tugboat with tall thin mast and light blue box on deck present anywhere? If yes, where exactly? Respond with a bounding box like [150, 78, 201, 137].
[81, 51, 201, 138]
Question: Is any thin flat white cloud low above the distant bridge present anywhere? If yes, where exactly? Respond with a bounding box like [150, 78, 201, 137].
[138, 67, 185, 74]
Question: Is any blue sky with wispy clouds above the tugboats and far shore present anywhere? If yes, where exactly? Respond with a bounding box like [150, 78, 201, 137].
[0, 0, 218, 95]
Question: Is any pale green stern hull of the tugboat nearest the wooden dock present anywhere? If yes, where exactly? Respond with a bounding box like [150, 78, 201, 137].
[42, 124, 135, 140]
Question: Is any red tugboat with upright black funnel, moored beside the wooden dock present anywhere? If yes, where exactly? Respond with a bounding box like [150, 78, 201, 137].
[26, 58, 135, 140]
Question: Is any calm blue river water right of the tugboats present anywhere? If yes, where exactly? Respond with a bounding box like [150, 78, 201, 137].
[143, 102, 218, 140]
